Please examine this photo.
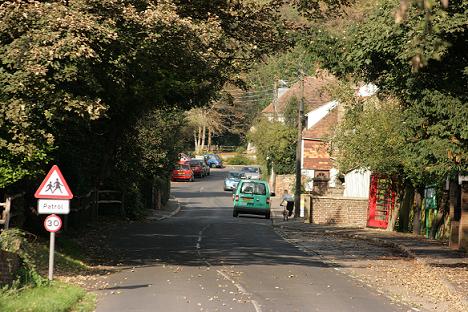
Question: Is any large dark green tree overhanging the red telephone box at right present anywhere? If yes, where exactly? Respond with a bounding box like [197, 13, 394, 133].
[316, 0, 468, 186]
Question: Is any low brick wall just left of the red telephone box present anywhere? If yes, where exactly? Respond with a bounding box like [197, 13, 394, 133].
[311, 196, 368, 227]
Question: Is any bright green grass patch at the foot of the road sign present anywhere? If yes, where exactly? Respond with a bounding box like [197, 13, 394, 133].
[0, 282, 95, 312]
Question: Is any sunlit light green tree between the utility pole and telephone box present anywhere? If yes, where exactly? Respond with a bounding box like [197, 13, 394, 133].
[332, 97, 405, 176]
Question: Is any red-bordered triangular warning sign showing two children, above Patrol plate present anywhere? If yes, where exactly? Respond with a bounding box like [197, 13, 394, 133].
[34, 165, 73, 199]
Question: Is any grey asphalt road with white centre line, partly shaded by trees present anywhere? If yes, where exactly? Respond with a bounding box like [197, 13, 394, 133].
[97, 169, 408, 312]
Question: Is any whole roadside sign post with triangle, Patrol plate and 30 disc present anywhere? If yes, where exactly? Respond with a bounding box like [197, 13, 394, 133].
[34, 165, 73, 281]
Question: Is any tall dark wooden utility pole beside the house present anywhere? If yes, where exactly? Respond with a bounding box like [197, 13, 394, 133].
[294, 70, 304, 218]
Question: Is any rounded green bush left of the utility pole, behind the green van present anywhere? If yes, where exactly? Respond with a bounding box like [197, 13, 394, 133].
[247, 119, 297, 174]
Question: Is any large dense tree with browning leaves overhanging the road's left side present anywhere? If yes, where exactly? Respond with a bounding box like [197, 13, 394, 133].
[0, 0, 287, 222]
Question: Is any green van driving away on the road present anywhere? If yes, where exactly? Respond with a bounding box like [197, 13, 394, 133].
[232, 179, 271, 219]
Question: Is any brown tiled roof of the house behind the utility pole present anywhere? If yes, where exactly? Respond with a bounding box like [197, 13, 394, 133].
[262, 71, 336, 114]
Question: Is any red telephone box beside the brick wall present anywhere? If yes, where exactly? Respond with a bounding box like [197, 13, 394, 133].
[367, 175, 396, 229]
